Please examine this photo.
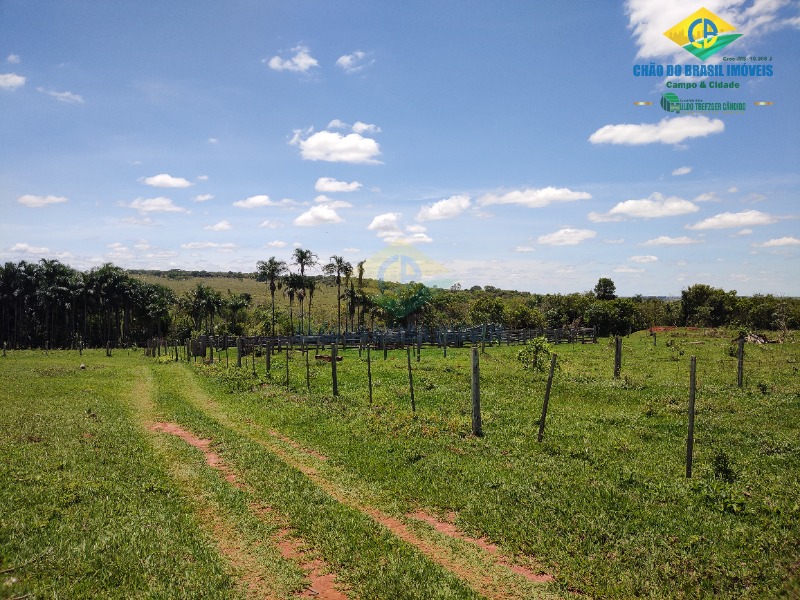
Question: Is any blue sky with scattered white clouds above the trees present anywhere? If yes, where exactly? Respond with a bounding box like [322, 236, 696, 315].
[0, 0, 800, 296]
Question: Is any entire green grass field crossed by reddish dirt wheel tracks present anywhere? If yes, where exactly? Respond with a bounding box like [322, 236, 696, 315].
[0, 330, 800, 599]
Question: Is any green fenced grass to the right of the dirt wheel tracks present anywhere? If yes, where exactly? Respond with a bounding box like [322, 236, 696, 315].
[195, 332, 800, 598]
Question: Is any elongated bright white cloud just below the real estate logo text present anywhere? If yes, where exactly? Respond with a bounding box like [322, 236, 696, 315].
[589, 116, 725, 146]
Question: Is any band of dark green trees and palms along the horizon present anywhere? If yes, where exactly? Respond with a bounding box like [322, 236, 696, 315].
[0, 254, 800, 348]
